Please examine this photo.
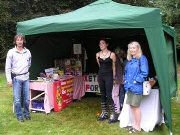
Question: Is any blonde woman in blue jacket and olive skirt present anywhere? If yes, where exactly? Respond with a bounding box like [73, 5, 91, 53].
[124, 41, 149, 133]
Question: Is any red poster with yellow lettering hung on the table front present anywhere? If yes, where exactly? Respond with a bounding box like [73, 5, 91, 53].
[54, 77, 73, 112]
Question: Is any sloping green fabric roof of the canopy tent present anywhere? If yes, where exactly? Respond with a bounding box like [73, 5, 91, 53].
[17, 0, 162, 35]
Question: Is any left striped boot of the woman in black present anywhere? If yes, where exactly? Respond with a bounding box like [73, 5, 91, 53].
[98, 102, 108, 121]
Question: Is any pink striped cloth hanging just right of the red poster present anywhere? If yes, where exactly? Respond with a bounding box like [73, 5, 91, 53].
[73, 76, 85, 100]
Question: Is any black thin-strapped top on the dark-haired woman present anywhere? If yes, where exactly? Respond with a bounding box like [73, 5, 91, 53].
[98, 53, 113, 74]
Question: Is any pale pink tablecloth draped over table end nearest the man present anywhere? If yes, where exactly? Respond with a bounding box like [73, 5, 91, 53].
[30, 82, 54, 113]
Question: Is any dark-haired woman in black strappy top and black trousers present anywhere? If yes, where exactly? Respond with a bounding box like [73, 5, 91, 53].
[96, 39, 117, 123]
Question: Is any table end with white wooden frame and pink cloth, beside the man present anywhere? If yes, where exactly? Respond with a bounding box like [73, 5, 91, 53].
[30, 81, 54, 113]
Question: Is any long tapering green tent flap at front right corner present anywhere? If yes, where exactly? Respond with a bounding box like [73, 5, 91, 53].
[145, 28, 172, 131]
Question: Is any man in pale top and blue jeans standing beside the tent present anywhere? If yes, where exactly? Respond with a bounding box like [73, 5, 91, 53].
[5, 34, 31, 122]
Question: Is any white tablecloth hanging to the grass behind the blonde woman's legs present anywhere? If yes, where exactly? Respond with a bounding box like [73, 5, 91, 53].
[119, 89, 162, 132]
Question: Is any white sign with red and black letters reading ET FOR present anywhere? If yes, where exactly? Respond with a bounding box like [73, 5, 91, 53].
[84, 74, 100, 93]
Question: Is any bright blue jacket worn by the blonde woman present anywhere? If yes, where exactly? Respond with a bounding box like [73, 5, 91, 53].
[124, 55, 149, 95]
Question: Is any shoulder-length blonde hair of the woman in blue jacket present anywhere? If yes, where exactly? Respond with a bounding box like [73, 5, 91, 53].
[127, 41, 142, 61]
